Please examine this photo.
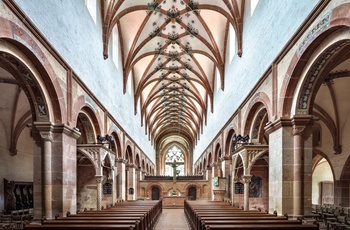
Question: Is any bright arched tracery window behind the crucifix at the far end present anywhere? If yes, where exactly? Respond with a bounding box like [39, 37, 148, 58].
[165, 146, 185, 176]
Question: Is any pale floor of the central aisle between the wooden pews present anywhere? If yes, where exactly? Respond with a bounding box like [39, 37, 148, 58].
[156, 209, 190, 230]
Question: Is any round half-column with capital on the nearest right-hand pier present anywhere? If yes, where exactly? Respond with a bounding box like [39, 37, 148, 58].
[292, 116, 312, 216]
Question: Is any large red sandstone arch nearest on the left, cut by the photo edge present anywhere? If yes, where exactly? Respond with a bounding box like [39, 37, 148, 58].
[0, 17, 68, 123]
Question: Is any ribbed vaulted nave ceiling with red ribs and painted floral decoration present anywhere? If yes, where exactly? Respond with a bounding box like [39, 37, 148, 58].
[101, 0, 244, 153]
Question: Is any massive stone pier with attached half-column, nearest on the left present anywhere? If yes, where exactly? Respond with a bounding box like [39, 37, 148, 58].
[31, 122, 80, 219]
